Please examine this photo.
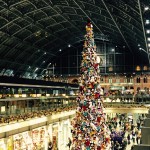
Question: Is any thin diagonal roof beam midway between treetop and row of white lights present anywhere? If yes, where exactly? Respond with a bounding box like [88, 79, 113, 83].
[101, 0, 133, 54]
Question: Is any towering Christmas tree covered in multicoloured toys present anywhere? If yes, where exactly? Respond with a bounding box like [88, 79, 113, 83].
[72, 21, 111, 150]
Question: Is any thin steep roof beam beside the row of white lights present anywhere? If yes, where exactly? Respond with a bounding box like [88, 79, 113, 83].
[138, 0, 150, 64]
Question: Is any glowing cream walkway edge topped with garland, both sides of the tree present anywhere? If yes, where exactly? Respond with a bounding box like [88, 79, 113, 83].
[0, 102, 149, 138]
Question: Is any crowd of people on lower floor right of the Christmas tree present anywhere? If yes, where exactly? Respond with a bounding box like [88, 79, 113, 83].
[107, 114, 144, 150]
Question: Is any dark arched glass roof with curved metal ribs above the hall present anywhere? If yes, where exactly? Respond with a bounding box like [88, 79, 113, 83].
[0, 0, 150, 75]
